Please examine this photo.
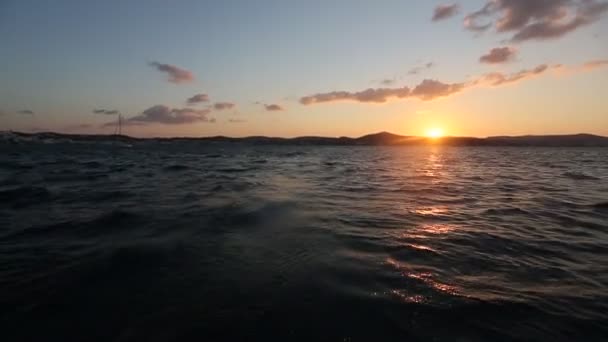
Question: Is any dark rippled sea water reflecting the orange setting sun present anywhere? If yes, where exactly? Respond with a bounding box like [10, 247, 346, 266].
[0, 142, 608, 341]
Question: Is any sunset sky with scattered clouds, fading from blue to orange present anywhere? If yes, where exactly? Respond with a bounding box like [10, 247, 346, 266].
[0, 0, 608, 137]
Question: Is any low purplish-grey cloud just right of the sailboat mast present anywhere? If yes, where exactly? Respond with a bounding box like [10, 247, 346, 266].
[113, 105, 215, 126]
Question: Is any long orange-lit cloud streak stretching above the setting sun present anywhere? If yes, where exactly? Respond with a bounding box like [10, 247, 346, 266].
[300, 60, 608, 105]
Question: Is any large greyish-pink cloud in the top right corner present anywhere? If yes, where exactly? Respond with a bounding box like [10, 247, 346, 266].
[464, 0, 608, 42]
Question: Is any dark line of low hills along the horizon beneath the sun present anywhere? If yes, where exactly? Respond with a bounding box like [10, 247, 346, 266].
[0, 132, 608, 147]
